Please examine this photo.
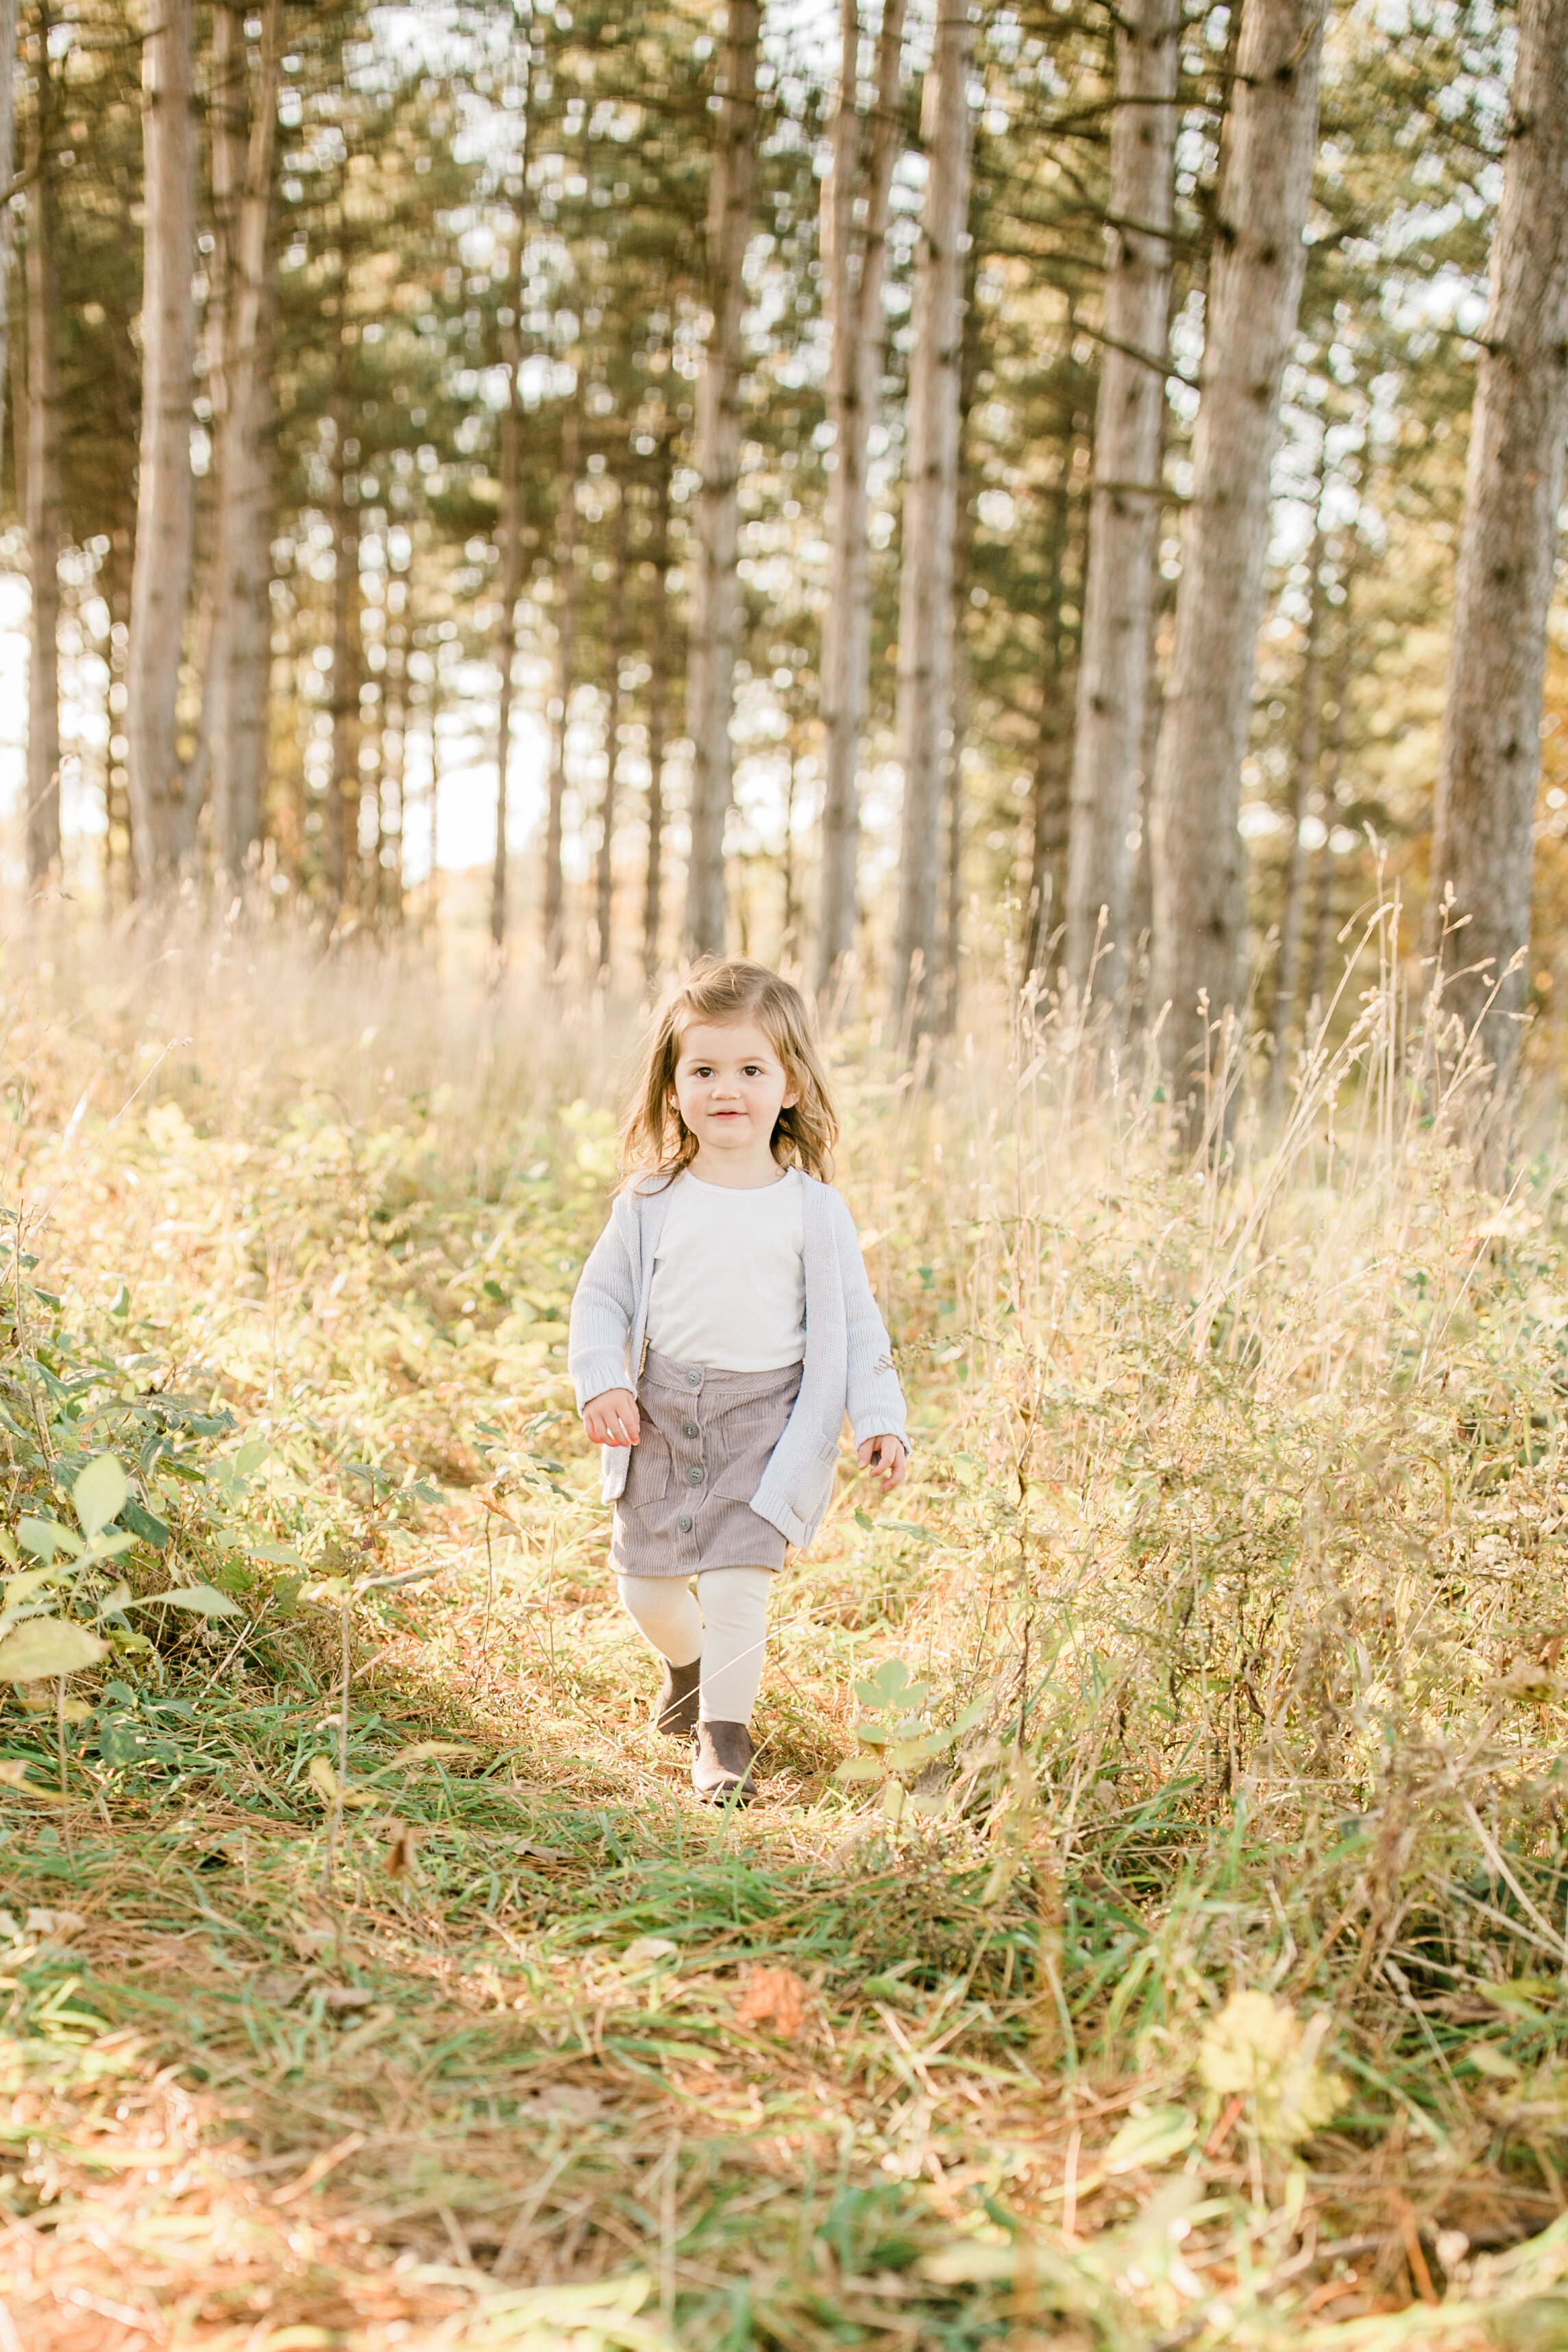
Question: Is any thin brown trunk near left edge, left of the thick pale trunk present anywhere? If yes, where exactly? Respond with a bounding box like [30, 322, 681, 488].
[21, 0, 66, 889]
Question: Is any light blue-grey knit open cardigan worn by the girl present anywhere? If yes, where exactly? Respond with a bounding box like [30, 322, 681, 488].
[567, 1176, 907, 1545]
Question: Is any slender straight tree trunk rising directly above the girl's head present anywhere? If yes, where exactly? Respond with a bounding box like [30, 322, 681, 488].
[687, 0, 761, 955]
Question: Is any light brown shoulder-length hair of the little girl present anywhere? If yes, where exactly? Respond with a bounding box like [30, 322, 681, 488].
[621, 955, 840, 1183]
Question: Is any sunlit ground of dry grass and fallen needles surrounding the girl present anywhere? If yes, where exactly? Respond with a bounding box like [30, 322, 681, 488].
[0, 936, 1568, 2352]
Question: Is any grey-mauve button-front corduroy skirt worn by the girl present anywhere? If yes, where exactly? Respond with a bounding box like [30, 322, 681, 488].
[609, 1348, 804, 1576]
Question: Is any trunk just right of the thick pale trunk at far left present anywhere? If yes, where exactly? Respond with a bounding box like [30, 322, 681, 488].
[207, 0, 282, 877]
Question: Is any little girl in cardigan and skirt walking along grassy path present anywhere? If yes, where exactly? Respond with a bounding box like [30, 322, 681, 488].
[569, 959, 910, 1804]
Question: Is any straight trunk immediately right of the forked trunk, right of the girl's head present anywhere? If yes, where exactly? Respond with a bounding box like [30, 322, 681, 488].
[894, 0, 973, 1030]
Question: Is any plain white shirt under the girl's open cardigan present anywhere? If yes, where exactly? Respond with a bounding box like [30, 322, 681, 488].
[649, 1169, 807, 1371]
